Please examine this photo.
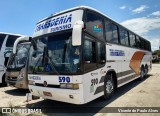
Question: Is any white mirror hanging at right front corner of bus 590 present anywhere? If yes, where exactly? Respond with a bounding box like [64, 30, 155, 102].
[72, 21, 84, 46]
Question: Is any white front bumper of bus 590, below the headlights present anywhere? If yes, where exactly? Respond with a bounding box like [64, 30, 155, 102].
[28, 85, 84, 104]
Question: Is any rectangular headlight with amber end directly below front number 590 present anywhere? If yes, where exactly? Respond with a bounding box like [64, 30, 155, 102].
[60, 83, 79, 89]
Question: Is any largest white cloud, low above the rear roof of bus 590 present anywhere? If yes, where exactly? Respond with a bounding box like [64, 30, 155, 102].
[121, 17, 160, 51]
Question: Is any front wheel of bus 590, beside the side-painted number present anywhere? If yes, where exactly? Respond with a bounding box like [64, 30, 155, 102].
[104, 74, 114, 99]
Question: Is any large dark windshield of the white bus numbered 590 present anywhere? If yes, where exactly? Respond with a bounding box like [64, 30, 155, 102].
[29, 32, 80, 74]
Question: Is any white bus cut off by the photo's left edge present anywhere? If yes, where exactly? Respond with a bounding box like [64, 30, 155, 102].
[0, 32, 23, 86]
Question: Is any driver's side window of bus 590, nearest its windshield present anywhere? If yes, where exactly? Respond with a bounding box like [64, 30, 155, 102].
[84, 37, 96, 71]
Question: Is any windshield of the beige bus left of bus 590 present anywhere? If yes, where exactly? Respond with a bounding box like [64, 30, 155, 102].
[7, 44, 30, 69]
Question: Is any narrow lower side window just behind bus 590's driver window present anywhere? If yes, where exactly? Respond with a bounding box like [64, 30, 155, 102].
[97, 42, 106, 65]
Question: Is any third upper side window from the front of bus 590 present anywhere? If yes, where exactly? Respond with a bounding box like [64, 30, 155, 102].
[119, 28, 129, 46]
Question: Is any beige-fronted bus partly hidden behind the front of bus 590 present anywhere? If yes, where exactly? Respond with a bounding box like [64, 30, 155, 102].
[5, 36, 31, 89]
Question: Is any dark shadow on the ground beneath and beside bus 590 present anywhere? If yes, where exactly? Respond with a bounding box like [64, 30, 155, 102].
[26, 75, 152, 116]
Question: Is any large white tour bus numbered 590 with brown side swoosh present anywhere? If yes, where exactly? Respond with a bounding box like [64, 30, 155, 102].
[28, 6, 152, 104]
